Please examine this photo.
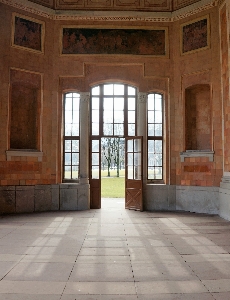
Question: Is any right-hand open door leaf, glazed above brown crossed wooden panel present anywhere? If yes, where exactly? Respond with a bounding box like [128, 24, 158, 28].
[125, 137, 143, 211]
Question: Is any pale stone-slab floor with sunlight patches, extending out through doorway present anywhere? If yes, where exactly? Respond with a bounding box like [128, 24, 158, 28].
[0, 199, 230, 300]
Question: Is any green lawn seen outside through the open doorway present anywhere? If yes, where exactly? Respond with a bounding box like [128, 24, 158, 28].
[101, 170, 125, 198]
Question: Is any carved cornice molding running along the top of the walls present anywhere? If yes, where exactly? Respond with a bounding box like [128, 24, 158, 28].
[0, 0, 217, 23]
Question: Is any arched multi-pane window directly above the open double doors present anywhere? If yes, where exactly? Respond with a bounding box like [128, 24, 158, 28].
[91, 84, 137, 136]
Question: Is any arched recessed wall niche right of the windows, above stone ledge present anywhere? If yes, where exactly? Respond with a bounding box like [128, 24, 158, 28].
[185, 84, 212, 151]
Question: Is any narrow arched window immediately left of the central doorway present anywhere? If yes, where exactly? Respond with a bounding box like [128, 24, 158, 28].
[63, 93, 80, 180]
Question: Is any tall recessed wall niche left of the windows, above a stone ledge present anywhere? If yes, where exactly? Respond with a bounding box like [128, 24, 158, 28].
[9, 69, 41, 150]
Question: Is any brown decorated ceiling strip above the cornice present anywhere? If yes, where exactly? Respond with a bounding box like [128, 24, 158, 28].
[29, 0, 202, 12]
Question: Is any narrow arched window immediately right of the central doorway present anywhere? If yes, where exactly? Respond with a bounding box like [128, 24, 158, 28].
[147, 93, 163, 180]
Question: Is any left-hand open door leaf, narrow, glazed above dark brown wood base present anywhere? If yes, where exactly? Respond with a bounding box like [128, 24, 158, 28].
[89, 138, 101, 209]
